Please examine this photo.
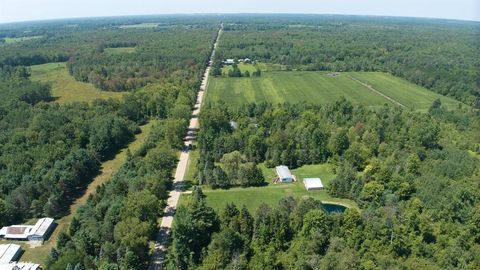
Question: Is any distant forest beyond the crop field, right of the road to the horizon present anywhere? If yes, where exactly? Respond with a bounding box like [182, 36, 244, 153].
[217, 16, 480, 108]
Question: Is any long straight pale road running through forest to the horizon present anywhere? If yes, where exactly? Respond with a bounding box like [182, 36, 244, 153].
[149, 25, 223, 270]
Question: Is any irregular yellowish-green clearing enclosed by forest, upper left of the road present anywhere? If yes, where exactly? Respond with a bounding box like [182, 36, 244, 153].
[30, 62, 126, 104]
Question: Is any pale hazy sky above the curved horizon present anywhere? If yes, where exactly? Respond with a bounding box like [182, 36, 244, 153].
[0, 0, 480, 23]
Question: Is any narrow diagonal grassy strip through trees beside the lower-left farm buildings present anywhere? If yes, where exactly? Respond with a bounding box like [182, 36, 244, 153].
[20, 121, 155, 264]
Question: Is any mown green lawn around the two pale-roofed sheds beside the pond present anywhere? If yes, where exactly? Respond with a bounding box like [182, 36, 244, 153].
[181, 164, 358, 213]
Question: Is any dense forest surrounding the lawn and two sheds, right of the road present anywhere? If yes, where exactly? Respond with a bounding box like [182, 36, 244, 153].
[169, 100, 480, 269]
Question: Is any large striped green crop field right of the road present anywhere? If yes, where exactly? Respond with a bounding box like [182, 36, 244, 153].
[207, 71, 459, 111]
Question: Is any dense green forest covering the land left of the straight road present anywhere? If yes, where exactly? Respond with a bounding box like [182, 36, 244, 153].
[0, 18, 218, 269]
